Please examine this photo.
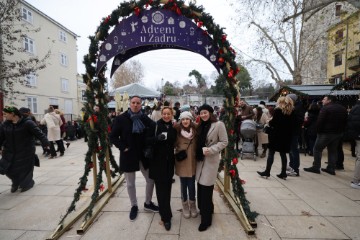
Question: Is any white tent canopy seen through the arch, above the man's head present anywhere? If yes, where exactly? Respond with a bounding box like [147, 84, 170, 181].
[111, 83, 161, 98]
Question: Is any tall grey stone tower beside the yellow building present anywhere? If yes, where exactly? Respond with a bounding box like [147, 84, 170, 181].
[299, 0, 358, 85]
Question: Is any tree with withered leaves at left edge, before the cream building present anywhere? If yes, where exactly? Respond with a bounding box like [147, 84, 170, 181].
[0, 0, 50, 99]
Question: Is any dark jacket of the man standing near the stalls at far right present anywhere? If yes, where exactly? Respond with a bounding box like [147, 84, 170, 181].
[316, 103, 347, 133]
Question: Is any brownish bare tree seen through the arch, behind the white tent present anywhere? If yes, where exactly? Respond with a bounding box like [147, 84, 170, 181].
[111, 60, 144, 89]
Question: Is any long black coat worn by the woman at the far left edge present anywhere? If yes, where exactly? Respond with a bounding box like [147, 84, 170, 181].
[0, 118, 49, 176]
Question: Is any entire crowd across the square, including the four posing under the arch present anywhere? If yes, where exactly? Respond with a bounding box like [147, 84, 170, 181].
[0, 94, 360, 231]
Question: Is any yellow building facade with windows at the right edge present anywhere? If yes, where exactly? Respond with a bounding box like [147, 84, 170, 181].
[327, 10, 360, 84]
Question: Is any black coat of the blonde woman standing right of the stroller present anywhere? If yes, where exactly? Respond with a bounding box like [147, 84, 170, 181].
[269, 108, 295, 153]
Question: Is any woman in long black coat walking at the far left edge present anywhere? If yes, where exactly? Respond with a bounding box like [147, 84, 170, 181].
[0, 107, 49, 193]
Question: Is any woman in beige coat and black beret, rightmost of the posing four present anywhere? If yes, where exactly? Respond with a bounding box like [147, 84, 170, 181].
[195, 104, 228, 232]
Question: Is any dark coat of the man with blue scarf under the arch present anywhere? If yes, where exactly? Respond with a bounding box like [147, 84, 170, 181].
[110, 112, 155, 172]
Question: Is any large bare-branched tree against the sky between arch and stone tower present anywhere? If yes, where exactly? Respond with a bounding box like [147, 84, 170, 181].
[229, 0, 330, 86]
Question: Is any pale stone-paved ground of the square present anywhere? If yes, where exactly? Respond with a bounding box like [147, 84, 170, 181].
[0, 140, 360, 240]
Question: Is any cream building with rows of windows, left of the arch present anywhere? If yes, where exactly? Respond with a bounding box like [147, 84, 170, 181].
[3, 1, 79, 119]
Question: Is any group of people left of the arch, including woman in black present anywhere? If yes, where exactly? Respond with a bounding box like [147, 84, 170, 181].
[0, 106, 84, 193]
